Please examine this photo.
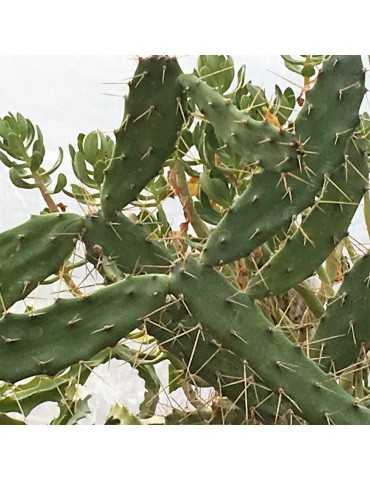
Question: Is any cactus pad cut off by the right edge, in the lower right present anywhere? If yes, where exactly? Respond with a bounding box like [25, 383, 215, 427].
[310, 253, 370, 371]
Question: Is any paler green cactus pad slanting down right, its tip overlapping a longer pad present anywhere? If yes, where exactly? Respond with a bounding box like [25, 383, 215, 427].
[180, 74, 299, 172]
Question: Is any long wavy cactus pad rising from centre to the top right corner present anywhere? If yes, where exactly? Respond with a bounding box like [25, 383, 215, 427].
[202, 55, 365, 265]
